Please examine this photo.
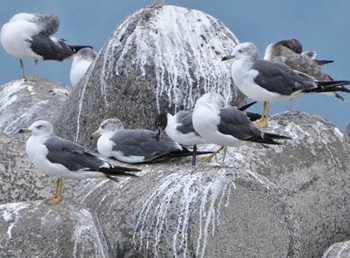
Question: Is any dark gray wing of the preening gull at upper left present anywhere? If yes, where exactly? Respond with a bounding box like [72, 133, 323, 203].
[27, 33, 74, 61]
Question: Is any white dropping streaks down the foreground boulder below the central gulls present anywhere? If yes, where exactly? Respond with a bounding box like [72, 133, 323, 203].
[133, 170, 235, 257]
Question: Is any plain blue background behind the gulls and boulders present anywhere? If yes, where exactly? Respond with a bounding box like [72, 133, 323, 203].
[0, 0, 350, 128]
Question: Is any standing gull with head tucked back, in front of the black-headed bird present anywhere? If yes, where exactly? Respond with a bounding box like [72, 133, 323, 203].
[192, 92, 290, 166]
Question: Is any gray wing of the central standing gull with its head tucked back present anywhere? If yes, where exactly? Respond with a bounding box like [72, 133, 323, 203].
[218, 107, 262, 140]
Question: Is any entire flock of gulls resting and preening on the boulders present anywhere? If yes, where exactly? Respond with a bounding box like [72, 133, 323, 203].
[0, 12, 350, 204]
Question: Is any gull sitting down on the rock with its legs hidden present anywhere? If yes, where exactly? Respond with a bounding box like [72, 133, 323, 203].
[91, 118, 212, 164]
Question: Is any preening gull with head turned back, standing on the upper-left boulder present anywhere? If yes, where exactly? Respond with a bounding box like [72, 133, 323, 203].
[0, 12, 91, 80]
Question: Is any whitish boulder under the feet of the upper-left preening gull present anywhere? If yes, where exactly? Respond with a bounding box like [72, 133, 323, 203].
[0, 78, 69, 134]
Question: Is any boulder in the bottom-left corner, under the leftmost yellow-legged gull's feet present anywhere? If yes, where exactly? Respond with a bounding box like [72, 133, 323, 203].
[0, 202, 108, 257]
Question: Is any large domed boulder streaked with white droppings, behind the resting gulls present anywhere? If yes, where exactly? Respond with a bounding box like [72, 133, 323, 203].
[55, 5, 245, 145]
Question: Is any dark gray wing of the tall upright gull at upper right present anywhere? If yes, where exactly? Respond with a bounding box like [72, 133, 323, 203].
[251, 59, 316, 96]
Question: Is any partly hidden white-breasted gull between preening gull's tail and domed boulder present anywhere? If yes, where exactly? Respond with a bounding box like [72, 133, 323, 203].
[70, 47, 97, 87]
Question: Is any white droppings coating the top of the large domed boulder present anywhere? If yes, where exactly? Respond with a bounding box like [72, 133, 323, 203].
[100, 5, 238, 110]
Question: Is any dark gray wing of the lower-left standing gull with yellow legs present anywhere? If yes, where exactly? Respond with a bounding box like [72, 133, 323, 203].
[44, 136, 104, 171]
